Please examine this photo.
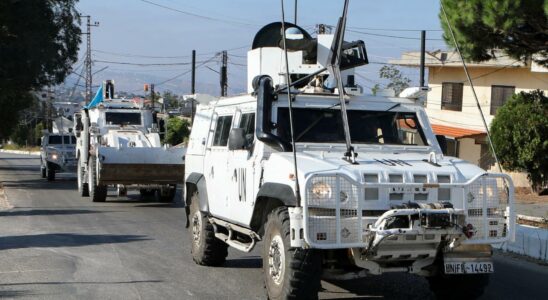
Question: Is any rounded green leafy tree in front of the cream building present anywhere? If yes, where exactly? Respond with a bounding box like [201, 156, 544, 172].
[491, 91, 548, 191]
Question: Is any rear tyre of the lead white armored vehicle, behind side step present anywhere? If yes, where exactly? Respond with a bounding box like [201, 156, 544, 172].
[188, 192, 228, 266]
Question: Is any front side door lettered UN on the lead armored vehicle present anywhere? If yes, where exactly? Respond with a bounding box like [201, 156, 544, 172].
[228, 110, 260, 225]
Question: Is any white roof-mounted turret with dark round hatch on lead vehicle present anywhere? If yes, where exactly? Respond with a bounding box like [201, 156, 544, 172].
[247, 22, 368, 93]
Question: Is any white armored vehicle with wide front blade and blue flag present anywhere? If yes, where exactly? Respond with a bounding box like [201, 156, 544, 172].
[74, 81, 185, 202]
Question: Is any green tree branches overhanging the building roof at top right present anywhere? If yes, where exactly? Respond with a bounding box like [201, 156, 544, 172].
[439, 0, 548, 66]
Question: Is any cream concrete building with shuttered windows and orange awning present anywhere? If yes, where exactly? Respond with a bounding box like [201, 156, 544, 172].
[389, 51, 548, 187]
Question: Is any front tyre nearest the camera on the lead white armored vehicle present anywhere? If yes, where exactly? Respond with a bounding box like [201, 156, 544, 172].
[263, 207, 321, 300]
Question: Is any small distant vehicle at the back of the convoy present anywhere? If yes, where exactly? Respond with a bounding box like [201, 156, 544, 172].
[40, 131, 76, 181]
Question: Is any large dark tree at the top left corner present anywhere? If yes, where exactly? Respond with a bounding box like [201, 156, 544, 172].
[0, 0, 80, 138]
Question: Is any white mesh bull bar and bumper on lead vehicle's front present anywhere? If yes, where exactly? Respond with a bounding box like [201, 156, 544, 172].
[290, 174, 515, 250]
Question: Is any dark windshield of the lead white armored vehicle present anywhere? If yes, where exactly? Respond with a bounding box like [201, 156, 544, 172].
[277, 108, 427, 146]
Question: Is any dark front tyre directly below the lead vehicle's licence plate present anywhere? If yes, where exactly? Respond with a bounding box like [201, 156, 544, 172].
[427, 270, 490, 299]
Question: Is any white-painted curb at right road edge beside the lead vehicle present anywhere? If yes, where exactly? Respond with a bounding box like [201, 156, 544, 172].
[493, 224, 548, 262]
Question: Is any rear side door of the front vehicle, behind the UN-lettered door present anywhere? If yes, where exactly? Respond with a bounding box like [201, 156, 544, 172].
[204, 110, 233, 218]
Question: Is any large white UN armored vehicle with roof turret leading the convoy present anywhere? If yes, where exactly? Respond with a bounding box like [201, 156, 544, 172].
[185, 5, 515, 299]
